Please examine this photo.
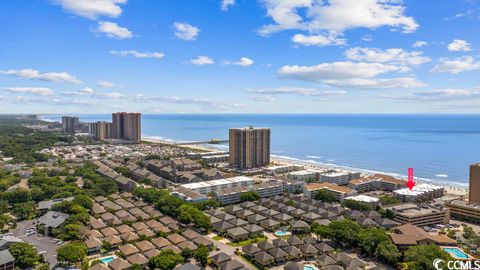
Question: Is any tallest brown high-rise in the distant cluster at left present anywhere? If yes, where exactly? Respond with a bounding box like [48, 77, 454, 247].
[112, 112, 142, 142]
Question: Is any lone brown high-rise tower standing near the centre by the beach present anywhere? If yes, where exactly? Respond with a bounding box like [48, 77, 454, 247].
[229, 127, 270, 169]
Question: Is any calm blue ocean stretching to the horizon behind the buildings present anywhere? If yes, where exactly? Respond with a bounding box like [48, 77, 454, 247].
[43, 114, 480, 186]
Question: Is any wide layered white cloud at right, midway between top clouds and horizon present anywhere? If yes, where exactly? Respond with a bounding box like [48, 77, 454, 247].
[278, 61, 425, 89]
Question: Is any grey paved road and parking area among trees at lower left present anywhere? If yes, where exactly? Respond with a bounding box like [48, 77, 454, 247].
[12, 220, 60, 267]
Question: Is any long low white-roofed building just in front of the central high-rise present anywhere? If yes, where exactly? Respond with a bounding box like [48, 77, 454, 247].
[181, 176, 255, 195]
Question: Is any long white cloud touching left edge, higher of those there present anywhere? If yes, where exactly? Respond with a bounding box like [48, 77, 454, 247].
[0, 68, 81, 84]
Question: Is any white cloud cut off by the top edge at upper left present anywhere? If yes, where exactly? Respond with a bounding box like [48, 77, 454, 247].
[54, 0, 127, 19]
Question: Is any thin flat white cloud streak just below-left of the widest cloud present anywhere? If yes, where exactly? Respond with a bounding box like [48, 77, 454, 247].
[248, 87, 346, 96]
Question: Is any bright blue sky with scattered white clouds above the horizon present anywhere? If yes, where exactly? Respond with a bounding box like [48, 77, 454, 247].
[0, 0, 480, 113]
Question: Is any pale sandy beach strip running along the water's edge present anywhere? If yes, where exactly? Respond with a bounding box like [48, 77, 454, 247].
[142, 136, 468, 196]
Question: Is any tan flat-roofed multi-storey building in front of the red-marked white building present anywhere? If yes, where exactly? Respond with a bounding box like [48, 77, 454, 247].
[388, 203, 450, 227]
